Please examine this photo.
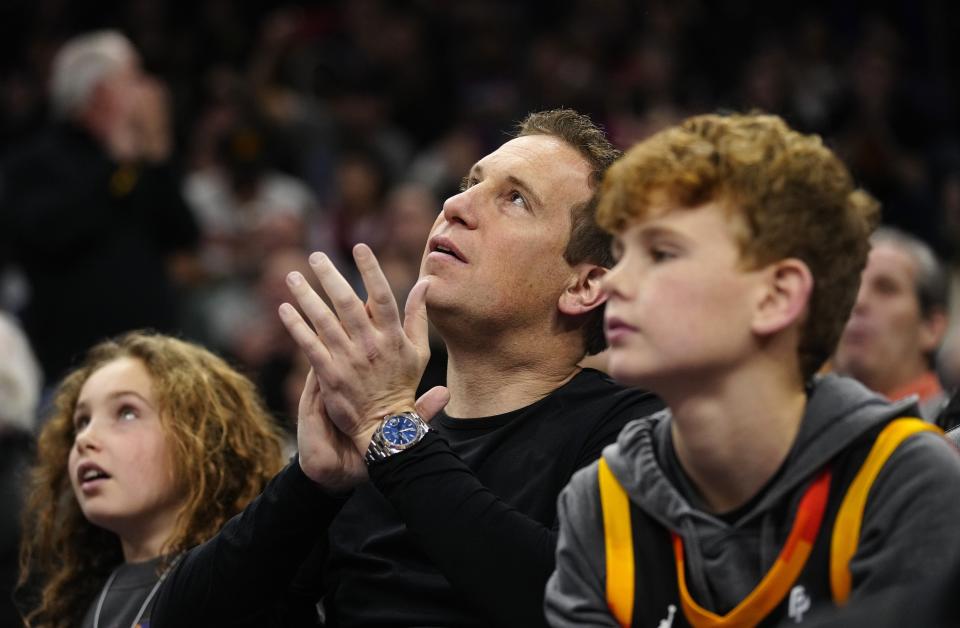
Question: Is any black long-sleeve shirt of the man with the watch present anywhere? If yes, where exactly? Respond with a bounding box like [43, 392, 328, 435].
[152, 370, 662, 628]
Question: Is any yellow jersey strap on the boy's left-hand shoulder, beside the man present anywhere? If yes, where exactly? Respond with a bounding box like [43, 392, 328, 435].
[598, 458, 634, 626]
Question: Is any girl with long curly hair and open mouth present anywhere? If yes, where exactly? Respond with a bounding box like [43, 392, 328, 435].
[18, 332, 283, 628]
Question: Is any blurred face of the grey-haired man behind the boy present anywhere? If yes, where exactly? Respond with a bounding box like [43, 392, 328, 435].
[834, 242, 940, 393]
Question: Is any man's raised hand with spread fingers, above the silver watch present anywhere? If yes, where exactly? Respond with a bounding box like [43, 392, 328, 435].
[280, 244, 432, 456]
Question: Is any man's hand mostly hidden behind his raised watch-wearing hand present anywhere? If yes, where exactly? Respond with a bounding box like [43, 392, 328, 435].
[297, 369, 367, 494]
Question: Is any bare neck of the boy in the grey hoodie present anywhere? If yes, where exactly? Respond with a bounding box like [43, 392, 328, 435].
[667, 364, 807, 513]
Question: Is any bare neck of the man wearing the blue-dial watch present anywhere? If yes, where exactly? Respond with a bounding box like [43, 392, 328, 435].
[438, 328, 583, 418]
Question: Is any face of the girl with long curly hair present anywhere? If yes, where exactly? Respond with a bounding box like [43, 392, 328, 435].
[68, 357, 183, 560]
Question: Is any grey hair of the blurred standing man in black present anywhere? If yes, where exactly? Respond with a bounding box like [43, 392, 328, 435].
[49, 30, 137, 118]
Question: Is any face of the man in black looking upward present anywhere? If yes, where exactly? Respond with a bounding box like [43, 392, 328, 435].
[420, 135, 591, 336]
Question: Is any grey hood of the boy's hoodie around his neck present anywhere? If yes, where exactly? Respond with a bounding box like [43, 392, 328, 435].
[603, 375, 920, 536]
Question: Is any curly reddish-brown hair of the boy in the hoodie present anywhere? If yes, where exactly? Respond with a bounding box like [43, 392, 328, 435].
[598, 114, 879, 378]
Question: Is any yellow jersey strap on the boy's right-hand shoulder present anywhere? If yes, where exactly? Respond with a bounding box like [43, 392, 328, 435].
[830, 418, 943, 606]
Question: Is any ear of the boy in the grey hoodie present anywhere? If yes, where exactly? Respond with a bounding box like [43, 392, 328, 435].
[752, 258, 813, 336]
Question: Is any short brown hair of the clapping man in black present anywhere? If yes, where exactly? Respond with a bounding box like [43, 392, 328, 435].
[516, 109, 621, 355]
